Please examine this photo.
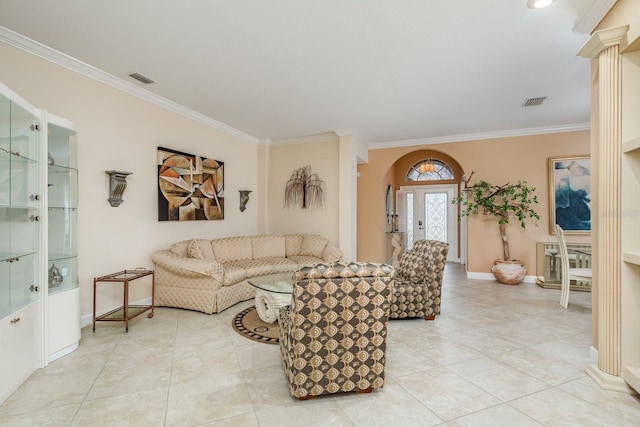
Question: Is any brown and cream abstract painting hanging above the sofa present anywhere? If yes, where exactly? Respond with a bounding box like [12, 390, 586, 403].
[158, 147, 224, 221]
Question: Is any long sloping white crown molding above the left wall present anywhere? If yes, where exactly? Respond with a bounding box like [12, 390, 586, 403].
[0, 26, 258, 144]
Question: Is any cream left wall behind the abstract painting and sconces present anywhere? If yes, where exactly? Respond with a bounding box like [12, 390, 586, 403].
[0, 43, 258, 320]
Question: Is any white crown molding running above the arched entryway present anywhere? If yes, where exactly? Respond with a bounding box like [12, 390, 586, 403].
[369, 123, 591, 150]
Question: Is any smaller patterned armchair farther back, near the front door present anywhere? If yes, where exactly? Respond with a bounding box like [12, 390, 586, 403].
[390, 240, 449, 320]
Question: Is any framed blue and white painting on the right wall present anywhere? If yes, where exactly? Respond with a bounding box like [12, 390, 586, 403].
[549, 156, 591, 234]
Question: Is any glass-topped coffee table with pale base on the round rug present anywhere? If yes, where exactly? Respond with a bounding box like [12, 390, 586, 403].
[247, 273, 293, 323]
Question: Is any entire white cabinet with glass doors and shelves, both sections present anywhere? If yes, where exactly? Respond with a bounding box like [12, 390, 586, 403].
[0, 83, 80, 403]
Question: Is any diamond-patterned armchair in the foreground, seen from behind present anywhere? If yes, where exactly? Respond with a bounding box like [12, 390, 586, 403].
[278, 263, 395, 399]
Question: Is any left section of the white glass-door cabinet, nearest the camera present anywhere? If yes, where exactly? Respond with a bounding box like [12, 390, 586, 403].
[0, 84, 44, 403]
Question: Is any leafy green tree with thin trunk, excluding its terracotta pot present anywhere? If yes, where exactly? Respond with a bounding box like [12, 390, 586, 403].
[451, 172, 540, 261]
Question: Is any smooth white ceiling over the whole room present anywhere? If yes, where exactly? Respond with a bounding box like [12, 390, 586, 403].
[0, 0, 615, 147]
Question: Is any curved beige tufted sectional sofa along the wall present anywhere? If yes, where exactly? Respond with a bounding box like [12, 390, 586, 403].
[151, 234, 342, 314]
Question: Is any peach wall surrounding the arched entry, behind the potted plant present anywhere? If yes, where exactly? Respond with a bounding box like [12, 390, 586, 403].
[358, 131, 590, 275]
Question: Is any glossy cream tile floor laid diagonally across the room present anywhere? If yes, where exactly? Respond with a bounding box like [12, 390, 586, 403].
[0, 264, 640, 427]
